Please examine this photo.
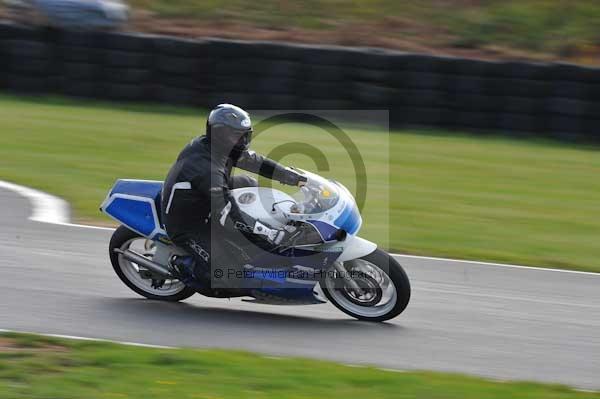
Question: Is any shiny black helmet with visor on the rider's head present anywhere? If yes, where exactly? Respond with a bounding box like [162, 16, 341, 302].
[206, 104, 252, 156]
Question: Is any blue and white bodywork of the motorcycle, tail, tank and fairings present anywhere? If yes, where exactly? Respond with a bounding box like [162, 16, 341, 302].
[100, 170, 377, 304]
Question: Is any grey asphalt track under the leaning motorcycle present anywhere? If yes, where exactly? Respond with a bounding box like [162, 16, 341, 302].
[0, 189, 600, 389]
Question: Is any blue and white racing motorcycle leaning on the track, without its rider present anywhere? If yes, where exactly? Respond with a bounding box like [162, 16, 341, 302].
[100, 169, 411, 321]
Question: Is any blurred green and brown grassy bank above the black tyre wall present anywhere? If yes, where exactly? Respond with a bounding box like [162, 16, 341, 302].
[120, 0, 600, 64]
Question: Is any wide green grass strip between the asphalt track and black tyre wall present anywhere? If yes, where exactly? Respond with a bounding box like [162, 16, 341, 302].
[0, 96, 600, 272]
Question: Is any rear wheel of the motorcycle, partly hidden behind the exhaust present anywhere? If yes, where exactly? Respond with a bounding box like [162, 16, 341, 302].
[108, 226, 196, 302]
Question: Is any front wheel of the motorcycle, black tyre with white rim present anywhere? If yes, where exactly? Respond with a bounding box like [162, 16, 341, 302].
[321, 249, 410, 321]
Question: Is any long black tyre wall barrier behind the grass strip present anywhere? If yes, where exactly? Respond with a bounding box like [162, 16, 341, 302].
[0, 22, 600, 140]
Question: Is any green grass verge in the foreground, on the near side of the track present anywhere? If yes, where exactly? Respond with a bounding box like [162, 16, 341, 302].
[0, 334, 600, 399]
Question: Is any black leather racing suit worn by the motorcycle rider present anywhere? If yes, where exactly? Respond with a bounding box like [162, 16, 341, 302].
[161, 136, 298, 286]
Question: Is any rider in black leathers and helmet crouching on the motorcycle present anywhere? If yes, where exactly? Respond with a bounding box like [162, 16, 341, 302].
[161, 104, 306, 288]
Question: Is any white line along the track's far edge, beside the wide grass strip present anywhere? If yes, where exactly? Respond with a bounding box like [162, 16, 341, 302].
[0, 180, 600, 277]
